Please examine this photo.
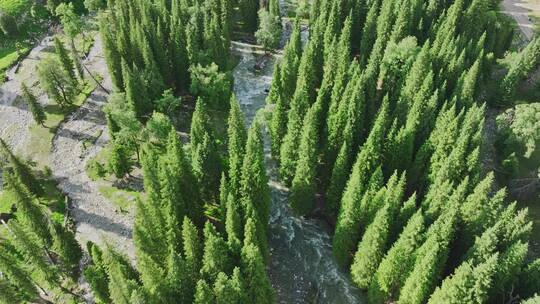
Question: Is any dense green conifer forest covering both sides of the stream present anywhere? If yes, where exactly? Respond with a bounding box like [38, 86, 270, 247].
[0, 0, 540, 304]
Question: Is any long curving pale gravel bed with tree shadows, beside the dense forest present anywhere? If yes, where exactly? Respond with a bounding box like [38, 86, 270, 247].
[50, 37, 135, 258]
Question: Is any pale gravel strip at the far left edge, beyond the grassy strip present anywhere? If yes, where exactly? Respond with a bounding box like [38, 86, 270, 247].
[0, 36, 53, 152]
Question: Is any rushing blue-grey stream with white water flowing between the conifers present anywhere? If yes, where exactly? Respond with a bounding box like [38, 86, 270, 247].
[233, 26, 366, 304]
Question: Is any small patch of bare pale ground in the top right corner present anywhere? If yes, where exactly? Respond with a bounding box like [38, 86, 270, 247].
[502, 0, 540, 40]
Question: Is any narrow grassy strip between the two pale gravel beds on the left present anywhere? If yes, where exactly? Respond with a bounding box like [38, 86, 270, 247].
[25, 83, 95, 168]
